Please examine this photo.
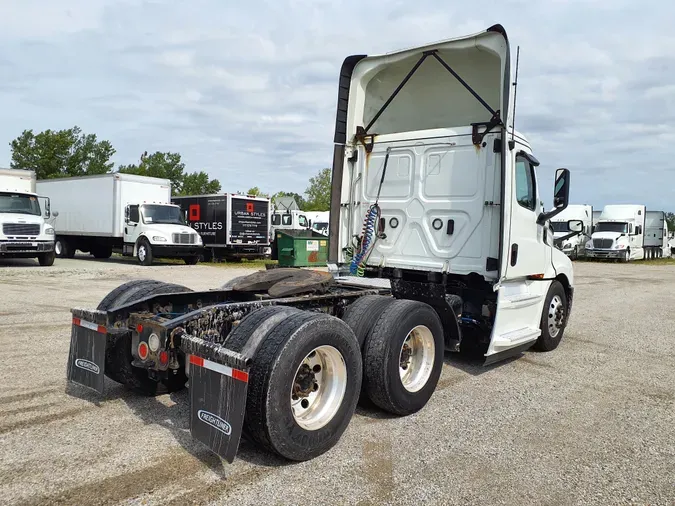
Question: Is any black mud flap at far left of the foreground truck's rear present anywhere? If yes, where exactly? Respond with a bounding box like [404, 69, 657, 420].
[67, 318, 108, 394]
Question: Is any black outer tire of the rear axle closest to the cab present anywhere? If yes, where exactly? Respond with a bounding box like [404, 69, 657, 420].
[363, 300, 445, 415]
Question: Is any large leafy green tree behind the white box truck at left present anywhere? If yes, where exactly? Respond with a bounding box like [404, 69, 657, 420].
[9, 126, 115, 179]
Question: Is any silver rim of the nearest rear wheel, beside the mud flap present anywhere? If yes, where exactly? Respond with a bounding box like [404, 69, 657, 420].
[290, 345, 347, 430]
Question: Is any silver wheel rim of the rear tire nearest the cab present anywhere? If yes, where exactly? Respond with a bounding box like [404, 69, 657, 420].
[399, 325, 436, 392]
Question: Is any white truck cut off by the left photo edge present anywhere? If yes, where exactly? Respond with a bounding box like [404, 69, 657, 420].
[0, 169, 54, 266]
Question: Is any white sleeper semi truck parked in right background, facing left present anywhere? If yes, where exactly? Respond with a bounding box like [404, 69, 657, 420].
[586, 204, 647, 262]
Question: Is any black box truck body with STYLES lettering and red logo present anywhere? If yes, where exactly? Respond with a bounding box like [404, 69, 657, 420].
[172, 193, 272, 261]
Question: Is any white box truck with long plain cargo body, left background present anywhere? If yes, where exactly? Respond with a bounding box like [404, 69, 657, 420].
[37, 173, 203, 265]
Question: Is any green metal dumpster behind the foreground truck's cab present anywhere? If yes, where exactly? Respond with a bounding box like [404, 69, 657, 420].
[275, 230, 328, 267]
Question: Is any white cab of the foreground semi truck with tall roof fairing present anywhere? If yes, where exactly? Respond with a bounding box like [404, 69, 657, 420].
[329, 25, 583, 363]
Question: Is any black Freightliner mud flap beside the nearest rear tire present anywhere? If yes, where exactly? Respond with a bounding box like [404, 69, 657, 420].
[189, 355, 248, 463]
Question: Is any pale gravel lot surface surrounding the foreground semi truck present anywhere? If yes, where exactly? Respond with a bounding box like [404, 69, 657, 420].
[0, 258, 675, 506]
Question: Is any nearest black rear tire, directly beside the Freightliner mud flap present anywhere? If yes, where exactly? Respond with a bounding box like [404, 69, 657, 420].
[245, 311, 362, 461]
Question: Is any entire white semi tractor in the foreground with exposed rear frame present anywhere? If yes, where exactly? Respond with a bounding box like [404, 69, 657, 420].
[67, 25, 582, 462]
